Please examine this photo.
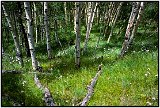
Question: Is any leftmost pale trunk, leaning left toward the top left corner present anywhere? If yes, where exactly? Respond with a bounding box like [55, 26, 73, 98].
[2, 3, 23, 66]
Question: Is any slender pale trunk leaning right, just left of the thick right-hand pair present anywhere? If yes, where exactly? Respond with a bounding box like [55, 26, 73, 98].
[107, 2, 123, 43]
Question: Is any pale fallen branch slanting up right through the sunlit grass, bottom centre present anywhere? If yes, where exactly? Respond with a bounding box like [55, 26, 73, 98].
[80, 64, 102, 106]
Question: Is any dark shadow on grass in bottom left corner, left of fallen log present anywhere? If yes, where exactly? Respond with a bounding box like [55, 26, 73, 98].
[1, 73, 42, 106]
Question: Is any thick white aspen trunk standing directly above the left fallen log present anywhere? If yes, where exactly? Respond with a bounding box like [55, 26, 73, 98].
[24, 2, 38, 70]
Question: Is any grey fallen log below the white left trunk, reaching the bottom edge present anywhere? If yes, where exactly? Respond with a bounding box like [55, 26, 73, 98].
[34, 74, 55, 106]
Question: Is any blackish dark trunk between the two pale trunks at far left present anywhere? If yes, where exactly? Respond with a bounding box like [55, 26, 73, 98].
[17, 2, 31, 57]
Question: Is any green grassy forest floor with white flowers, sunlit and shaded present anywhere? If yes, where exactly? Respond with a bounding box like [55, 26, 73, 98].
[2, 26, 158, 106]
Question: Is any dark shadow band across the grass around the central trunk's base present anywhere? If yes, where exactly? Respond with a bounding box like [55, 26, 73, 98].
[36, 29, 158, 82]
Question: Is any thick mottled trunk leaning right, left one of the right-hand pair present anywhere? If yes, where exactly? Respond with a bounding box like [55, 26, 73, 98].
[119, 2, 140, 57]
